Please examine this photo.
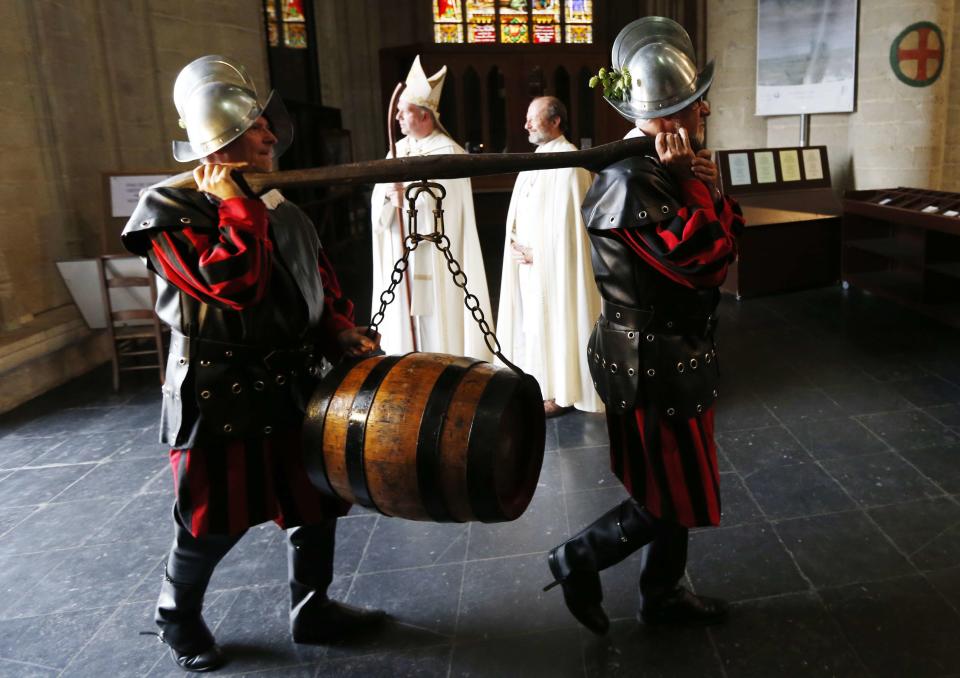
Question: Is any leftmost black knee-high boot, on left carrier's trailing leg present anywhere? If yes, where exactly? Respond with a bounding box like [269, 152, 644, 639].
[154, 516, 242, 672]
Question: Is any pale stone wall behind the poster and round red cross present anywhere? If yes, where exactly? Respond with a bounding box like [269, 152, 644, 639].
[707, 0, 960, 191]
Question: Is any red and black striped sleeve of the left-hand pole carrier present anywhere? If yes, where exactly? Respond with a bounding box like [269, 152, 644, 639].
[150, 198, 273, 311]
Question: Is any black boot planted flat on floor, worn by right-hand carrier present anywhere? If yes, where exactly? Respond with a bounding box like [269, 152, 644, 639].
[637, 521, 729, 626]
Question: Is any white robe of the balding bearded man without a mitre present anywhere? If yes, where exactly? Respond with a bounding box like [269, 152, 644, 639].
[497, 135, 603, 412]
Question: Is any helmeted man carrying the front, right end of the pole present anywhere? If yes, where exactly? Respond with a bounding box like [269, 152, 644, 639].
[548, 17, 743, 634]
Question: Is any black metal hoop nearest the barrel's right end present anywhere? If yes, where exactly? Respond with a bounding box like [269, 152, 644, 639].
[467, 370, 520, 523]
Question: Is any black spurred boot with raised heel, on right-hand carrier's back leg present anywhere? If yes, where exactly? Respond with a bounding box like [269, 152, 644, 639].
[544, 499, 657, 635]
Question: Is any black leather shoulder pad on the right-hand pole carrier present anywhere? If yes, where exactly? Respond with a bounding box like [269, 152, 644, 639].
[582, 156, 683, 231]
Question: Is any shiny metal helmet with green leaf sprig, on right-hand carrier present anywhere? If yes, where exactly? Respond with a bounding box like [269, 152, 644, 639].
[604, 16, 714, 122]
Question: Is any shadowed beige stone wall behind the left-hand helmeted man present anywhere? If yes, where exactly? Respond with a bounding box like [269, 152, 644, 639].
[0, 0, 267, 412]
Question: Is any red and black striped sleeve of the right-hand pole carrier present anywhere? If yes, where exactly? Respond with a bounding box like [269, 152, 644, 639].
[612, 179, 744, 289]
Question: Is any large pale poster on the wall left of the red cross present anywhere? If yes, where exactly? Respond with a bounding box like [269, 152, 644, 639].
[757, 0, 858, 115]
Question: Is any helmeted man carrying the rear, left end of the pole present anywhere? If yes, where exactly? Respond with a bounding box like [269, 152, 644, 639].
[122, 56, 385, 671]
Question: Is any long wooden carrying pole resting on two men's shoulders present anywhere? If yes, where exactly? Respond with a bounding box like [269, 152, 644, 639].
[160, 137, 656, 194]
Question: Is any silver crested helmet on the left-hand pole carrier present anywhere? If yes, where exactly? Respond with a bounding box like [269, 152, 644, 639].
[173, 54, 293, 162]
